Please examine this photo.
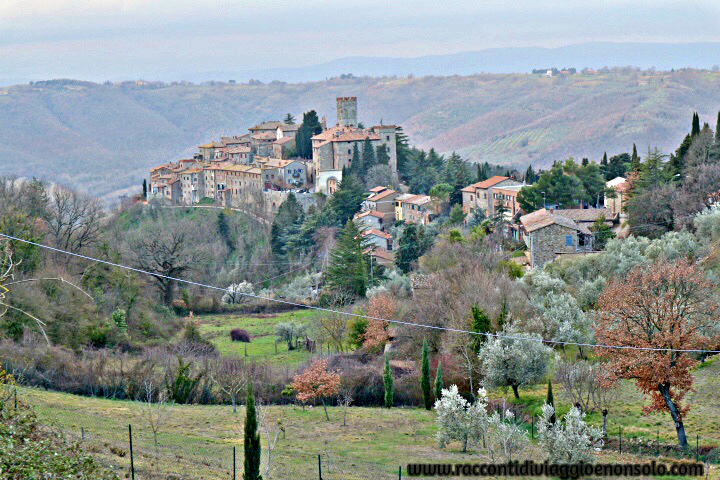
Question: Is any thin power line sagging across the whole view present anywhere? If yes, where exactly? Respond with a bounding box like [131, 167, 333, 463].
[0, 232, 720, 353]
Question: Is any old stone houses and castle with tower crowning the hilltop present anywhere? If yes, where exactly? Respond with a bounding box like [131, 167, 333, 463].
[148, 97, 397, 213]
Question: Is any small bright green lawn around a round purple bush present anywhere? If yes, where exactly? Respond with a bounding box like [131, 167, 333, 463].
[195, 310, 314, 365]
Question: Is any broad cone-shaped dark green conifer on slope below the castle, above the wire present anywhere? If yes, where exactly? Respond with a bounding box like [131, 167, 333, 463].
[325, 220, 368, 297]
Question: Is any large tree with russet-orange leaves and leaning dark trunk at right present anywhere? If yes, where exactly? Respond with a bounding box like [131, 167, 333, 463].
[595, 261, 718, 448]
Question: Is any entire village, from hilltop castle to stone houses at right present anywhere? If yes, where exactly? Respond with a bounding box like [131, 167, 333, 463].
[147, 97, 628, 268]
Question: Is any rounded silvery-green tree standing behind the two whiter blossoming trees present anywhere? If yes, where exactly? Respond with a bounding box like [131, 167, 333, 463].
[479, 326, 552, 398]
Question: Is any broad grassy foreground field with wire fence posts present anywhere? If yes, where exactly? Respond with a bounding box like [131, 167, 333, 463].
[20, 352, 720, 480]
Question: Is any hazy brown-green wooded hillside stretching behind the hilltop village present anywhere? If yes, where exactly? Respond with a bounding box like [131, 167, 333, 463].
[0, 69, 720, 196]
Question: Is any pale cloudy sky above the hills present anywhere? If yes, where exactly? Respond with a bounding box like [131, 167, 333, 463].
[0, 0, 720, 83]
